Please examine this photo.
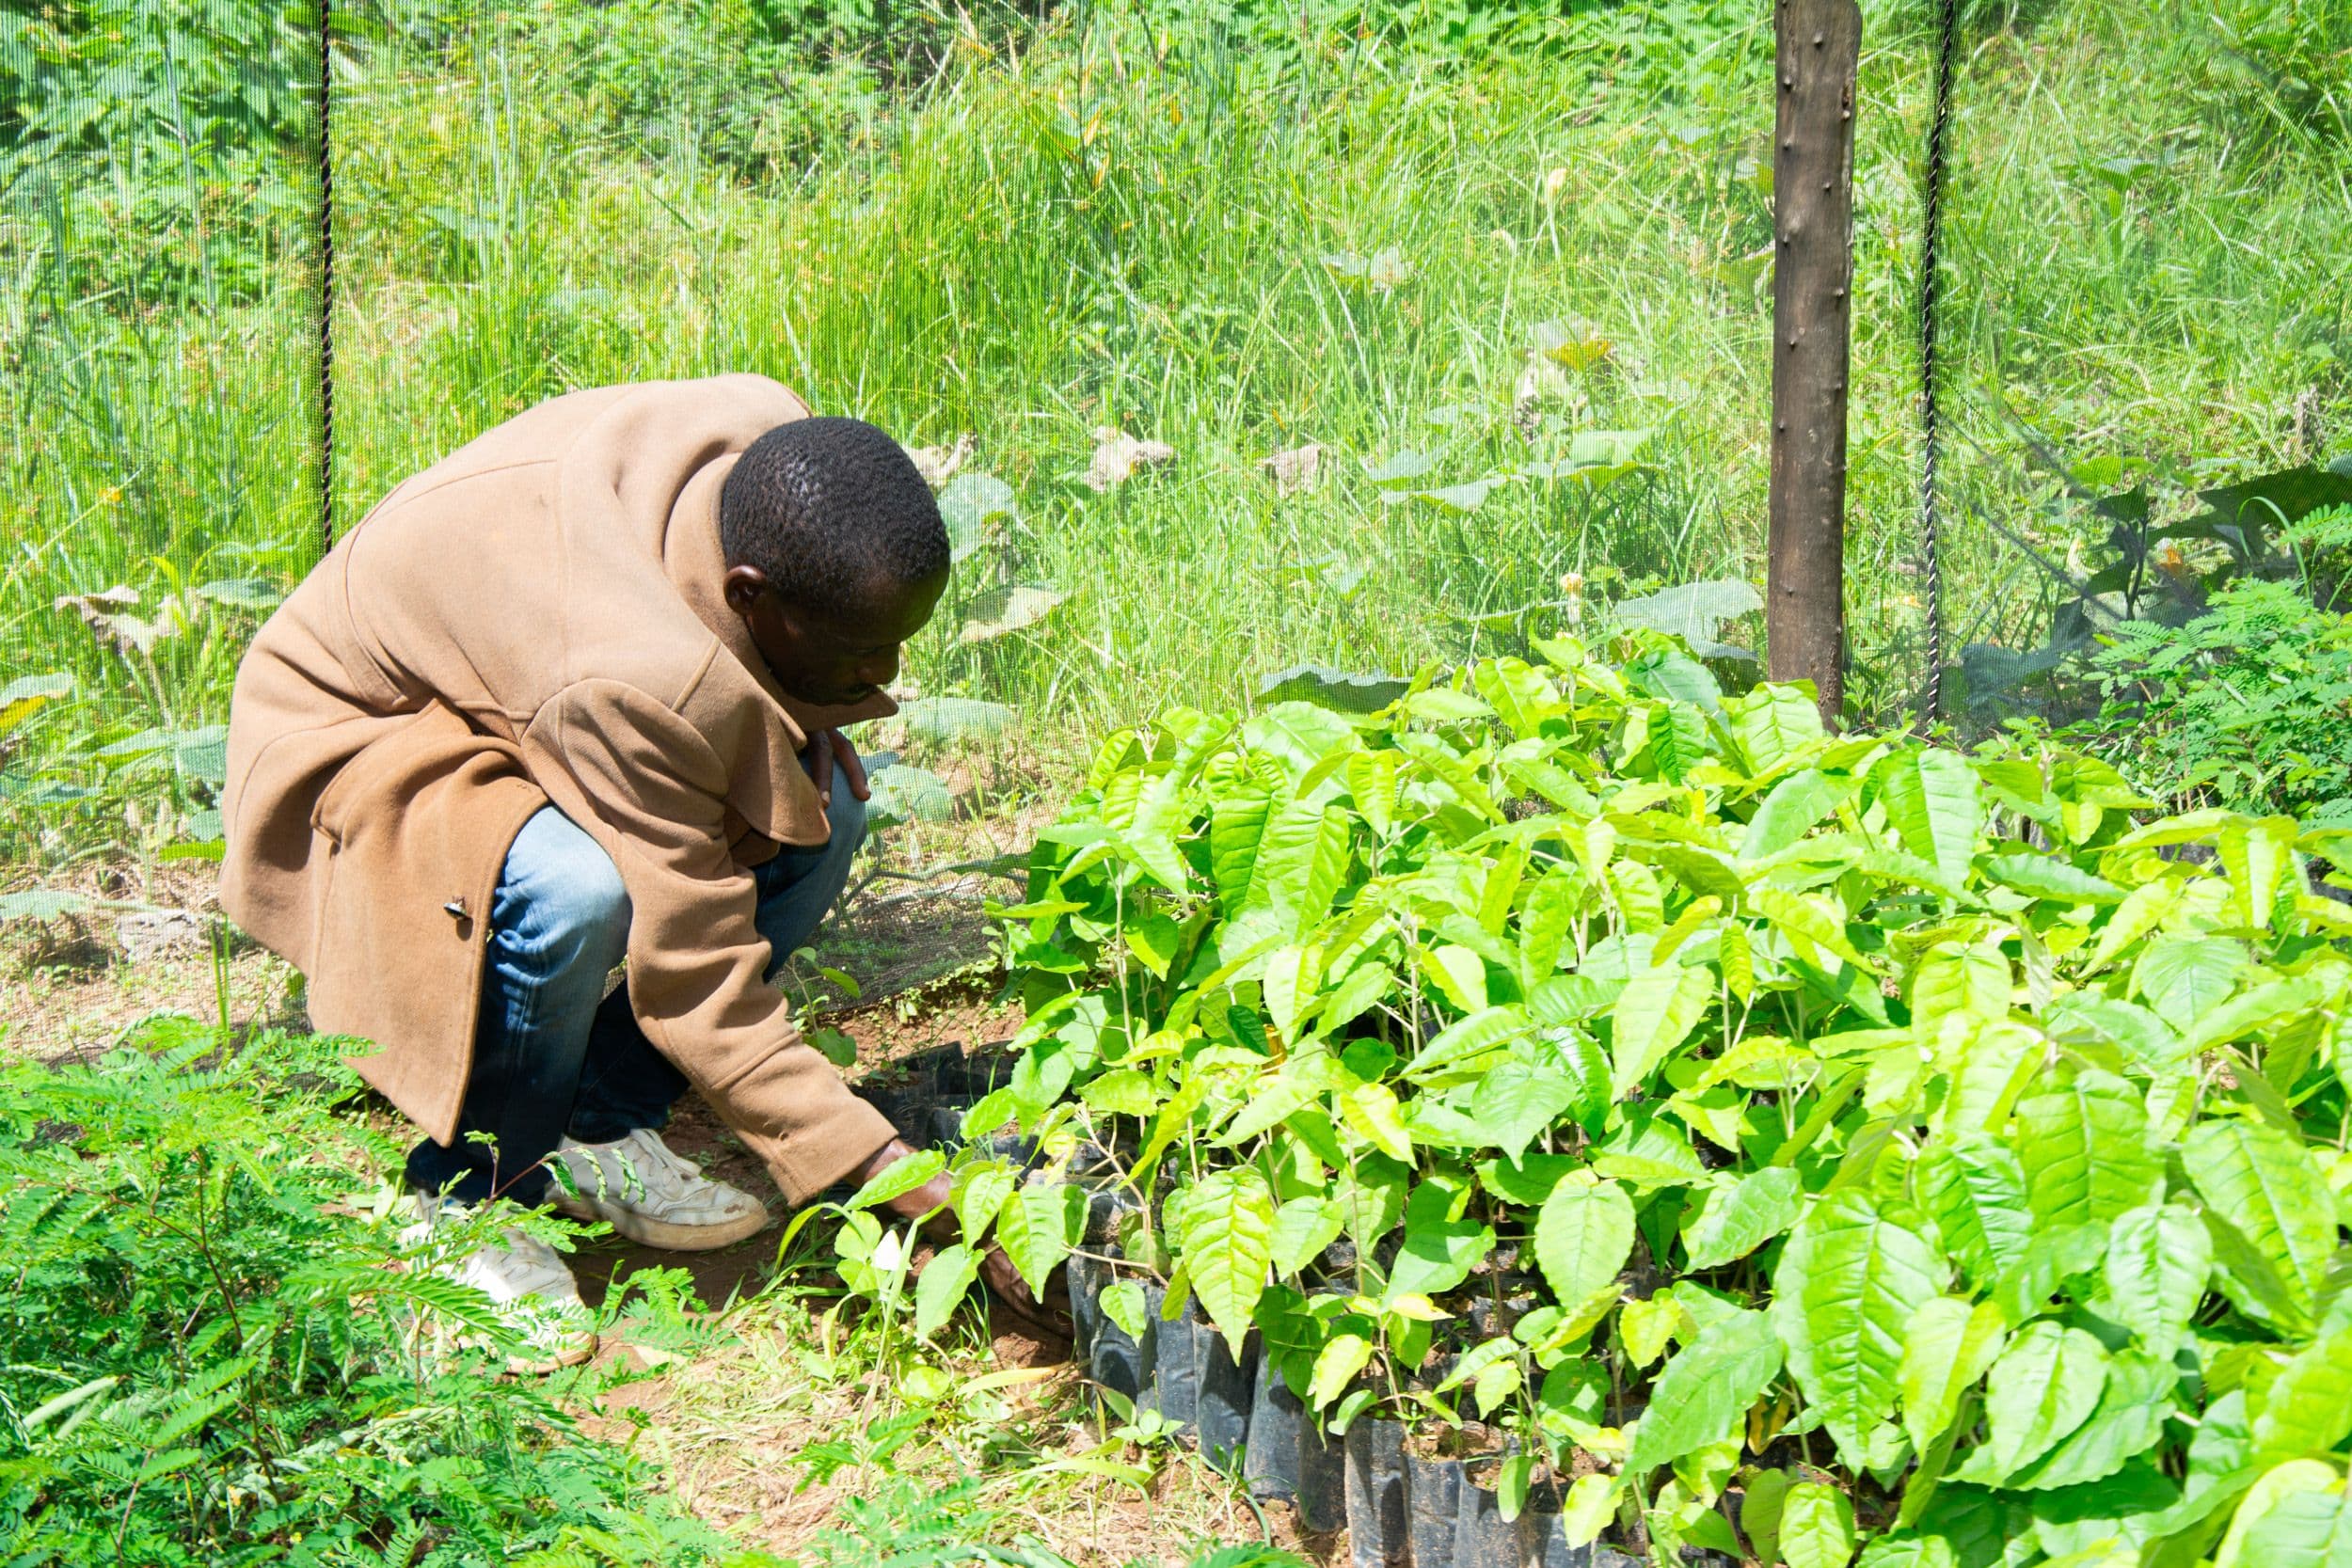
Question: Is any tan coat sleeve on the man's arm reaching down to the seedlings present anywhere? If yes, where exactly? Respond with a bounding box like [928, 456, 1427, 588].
[530, 682, 894, 1204]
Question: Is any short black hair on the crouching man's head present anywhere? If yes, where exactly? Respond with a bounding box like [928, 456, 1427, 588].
[720, 416, 948, 611]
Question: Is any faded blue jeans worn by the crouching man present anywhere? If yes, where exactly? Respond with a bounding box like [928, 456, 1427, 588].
[407, 778, 866, 1204]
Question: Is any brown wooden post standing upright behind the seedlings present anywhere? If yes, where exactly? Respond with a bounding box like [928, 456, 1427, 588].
[1764, 0, 1863, 724]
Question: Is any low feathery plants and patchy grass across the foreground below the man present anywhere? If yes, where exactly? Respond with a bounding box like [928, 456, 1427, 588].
[0, 1018, 1327, 1568]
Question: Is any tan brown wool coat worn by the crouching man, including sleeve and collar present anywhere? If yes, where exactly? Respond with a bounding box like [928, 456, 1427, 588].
[221, 376, 892, 1201]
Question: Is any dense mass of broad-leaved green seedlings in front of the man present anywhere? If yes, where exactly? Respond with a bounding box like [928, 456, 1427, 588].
[936, 637, 2352, 1568]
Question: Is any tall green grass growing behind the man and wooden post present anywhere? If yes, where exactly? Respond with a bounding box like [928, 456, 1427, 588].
[0, 0, 2352, 860]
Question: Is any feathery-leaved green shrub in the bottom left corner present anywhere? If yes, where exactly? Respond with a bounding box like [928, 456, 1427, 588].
[0, 1022, 748, 1568]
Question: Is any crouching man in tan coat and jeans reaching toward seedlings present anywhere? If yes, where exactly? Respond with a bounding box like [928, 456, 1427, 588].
[221, 376, 1035, 1369]
